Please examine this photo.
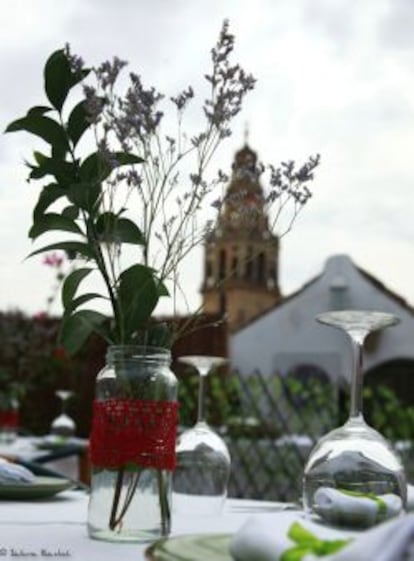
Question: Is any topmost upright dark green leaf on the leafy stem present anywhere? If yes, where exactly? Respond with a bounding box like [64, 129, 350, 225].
[44, 49, 72, 111]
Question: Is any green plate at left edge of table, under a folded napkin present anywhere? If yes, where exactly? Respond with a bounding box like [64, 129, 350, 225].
[0, 476, 73, 501]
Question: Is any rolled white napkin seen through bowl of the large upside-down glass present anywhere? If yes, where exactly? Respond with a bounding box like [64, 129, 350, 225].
[313, 487, 403, 528]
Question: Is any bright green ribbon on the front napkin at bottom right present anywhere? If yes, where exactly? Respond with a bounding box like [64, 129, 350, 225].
[280, 522, 352, 561]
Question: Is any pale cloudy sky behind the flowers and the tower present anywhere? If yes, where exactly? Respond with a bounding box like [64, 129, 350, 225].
[0, 0, 414, 313]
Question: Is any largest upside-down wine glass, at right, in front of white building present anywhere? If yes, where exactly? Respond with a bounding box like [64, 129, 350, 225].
[303, 310, 406, 527]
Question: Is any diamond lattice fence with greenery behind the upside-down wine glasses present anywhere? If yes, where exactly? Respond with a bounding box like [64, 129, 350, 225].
[180, 372, 414, 501]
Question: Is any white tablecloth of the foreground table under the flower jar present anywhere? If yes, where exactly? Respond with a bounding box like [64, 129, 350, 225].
[0, 491, 298, 561]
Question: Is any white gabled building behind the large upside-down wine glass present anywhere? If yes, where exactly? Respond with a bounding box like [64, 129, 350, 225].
[229, 255, 414, 393]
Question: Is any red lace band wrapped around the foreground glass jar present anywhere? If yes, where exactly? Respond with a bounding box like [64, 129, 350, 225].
[90, 399, 178, 470]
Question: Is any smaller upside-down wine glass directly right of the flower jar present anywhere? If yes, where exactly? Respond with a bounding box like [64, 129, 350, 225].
[173, 355, 230, 516]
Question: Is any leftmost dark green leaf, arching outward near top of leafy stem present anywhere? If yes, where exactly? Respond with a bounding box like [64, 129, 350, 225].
[5, 113, 68, 154]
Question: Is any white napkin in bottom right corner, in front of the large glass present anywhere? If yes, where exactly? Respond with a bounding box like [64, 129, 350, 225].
[230, 514, 414, 561]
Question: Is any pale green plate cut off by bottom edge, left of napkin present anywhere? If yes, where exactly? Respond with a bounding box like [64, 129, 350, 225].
[145, 534, 232, 561]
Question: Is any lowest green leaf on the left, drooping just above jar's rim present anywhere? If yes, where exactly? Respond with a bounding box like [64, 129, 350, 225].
[59, 310, 107, 355]
